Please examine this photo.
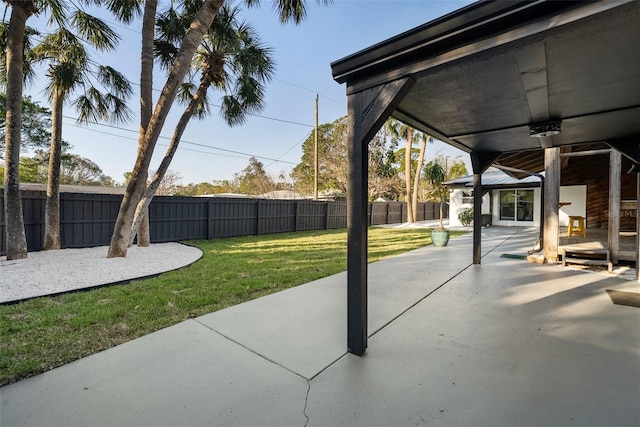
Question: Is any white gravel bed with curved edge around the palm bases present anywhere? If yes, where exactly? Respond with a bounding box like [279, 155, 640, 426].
[0, 243, 202, 303]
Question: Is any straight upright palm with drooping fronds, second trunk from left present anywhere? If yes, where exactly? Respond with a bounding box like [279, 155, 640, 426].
[34, 15, 131, 250]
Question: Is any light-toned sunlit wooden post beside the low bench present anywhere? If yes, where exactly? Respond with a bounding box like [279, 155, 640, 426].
[542, 147, 560, 262]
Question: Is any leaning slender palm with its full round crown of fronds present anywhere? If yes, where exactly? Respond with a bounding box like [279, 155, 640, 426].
[129, 6, 274, 244]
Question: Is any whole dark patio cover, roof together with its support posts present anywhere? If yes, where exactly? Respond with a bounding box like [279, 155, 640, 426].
[331, 0, 640, 355]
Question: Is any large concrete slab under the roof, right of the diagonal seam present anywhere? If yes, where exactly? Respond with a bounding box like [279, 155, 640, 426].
[307, 232, 640, 426]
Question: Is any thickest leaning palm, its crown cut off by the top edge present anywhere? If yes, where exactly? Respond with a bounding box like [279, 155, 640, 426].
[107, 0, 330, 258]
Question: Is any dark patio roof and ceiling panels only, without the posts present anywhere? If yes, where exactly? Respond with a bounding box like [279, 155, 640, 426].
[331, 0, 640, 171]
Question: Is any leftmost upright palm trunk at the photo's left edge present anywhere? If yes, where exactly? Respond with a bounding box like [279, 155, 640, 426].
[4, 4, 29, 260]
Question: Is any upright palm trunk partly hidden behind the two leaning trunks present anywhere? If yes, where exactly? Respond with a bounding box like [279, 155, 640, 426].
[135, 0, 158, 247]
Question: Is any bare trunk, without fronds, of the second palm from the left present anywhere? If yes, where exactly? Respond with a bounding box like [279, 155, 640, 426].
[42, 91, 63, 251]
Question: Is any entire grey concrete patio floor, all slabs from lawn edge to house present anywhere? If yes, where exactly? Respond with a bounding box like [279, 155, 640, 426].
[0, 227, 640, 427]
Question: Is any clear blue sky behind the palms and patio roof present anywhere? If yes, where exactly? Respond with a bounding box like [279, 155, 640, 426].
[24, 0, 471, 185]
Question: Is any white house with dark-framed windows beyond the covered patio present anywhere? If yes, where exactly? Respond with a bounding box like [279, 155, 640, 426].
[446, 170, 588, 231]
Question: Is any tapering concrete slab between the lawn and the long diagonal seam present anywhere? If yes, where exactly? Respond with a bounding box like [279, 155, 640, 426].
[198, 230, 526, 379]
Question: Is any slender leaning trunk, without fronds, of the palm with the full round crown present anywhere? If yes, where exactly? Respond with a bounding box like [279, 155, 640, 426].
[129, 85, 202, 244]
